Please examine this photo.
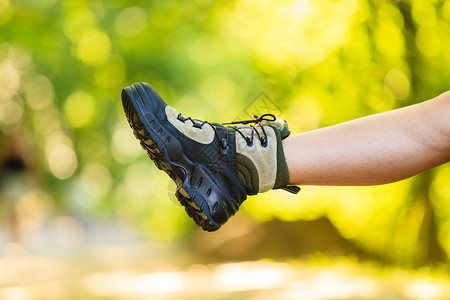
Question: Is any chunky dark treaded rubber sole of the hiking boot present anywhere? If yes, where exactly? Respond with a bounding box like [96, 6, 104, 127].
[122, 83, 228, 231]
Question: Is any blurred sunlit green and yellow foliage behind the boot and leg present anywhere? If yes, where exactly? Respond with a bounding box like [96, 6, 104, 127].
[0, 0, 450, 264]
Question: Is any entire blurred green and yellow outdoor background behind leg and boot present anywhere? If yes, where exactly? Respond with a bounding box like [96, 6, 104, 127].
[0, 0, 450, 300]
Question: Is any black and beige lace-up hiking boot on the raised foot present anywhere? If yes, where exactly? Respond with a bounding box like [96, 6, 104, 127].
[122, 83, 300, 231]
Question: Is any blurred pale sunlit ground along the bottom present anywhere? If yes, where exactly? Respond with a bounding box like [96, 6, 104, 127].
[0, 220, 450, 300]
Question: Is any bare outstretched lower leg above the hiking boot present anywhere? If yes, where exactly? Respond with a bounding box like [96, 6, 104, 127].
[283, 91, 450, 186]
